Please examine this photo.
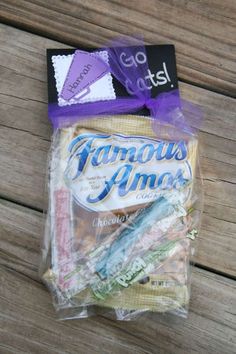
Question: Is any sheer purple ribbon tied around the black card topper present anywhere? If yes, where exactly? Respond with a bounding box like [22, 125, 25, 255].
[48, 42, 201, 134]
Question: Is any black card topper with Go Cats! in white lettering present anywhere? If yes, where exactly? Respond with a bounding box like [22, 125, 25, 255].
[47, 45, 178, 114]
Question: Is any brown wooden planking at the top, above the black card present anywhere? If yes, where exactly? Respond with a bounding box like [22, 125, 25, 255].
[0, 0, 236, 97]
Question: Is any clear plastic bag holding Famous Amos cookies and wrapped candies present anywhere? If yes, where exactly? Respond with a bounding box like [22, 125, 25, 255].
[41, 112, 202, 320]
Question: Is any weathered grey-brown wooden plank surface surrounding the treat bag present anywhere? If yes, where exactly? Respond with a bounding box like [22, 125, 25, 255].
[0, 0, 236, 354]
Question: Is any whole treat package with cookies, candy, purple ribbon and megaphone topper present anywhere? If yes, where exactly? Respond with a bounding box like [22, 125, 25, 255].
[41, 40, 202, 320]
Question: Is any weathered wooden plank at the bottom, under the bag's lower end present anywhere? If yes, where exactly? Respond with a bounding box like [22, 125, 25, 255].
[0, 200, 236, 354]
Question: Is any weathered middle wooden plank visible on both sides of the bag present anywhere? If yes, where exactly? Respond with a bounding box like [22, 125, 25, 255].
[0, 25, 236, 276]
